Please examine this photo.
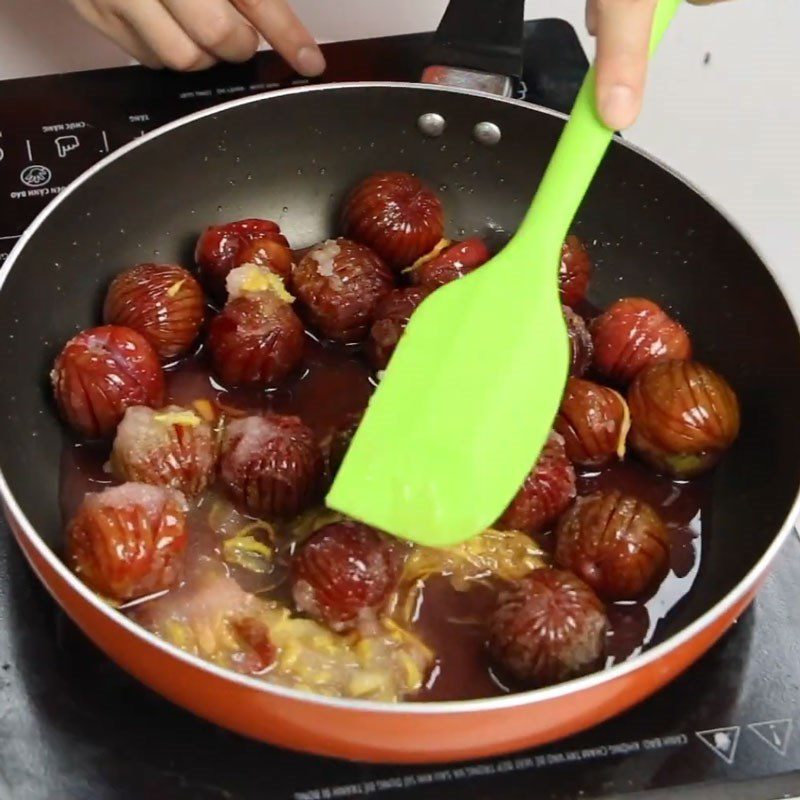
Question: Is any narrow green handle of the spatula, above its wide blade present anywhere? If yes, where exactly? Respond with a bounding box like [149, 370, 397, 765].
[512, 0, 681, 256]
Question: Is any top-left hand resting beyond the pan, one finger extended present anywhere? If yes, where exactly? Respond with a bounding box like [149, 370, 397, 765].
[69, 0, 325, 77]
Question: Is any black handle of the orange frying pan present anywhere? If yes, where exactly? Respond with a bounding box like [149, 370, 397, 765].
[428, 0, 525, 78]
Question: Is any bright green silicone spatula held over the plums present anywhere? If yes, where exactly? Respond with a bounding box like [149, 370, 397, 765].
[327, 0, 680, 547]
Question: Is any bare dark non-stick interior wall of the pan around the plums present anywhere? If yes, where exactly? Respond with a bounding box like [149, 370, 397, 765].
[0, 85, 800, 648]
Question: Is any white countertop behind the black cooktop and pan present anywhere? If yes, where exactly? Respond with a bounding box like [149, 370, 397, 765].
[0, 0, 800, 308]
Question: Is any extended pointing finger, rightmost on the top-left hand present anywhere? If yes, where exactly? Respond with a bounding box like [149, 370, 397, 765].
[232, 0, 325, 77]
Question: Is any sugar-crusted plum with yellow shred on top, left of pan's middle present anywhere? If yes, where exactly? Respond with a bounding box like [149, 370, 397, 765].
[111, 406, 217, 497]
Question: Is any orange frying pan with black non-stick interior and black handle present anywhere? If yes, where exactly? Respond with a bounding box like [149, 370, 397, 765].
[0, 0, 800, 761]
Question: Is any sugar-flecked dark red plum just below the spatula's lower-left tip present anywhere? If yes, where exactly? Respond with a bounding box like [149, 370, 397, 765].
[292, 522, 401, 631]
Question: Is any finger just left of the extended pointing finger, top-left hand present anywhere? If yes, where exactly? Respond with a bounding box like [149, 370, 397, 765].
[162, 0, 258, 61]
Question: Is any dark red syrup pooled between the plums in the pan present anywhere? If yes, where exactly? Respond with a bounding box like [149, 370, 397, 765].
[60, 336, 708, 700]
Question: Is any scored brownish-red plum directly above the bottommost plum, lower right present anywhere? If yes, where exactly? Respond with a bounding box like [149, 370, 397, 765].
[555, 491, 670, 601]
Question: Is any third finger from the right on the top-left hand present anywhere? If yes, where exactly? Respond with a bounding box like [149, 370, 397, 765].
[113, 0, 216, 72]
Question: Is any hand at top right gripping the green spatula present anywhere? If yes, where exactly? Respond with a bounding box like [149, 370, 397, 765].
[586, 0, 732, 130]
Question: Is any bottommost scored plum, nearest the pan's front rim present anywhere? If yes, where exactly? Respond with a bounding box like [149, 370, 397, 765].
[488, 567, 608, 688]
